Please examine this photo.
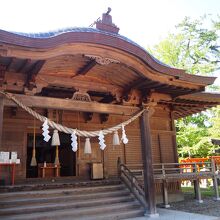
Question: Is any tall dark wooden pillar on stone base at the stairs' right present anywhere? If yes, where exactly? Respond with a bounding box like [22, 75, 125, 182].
[140, 108, 158, 217]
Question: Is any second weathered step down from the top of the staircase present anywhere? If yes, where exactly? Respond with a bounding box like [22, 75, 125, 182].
[0, 189, 130, 209]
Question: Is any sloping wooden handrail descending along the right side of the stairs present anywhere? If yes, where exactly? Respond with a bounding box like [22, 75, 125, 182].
[118, 158, 147, 209]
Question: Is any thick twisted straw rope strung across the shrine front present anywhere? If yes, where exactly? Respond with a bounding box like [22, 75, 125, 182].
[0, 91, 148, 138]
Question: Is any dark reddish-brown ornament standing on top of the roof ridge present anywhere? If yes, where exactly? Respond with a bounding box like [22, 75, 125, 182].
[95, 7, 119, 34]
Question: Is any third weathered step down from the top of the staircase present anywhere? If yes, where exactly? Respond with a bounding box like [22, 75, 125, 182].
[0, 196, 135, 216]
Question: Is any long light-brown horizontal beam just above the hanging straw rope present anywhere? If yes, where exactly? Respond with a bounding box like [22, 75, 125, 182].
[0, 94, 140, 115]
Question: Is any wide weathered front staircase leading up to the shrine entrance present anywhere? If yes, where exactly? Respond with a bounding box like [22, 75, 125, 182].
[0, 183, 144, 220]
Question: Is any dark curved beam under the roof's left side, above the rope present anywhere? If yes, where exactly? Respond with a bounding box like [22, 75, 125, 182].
[26, 60, 45, 89]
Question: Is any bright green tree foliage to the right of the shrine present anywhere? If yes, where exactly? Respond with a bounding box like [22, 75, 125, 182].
[150, 16, 220, 157]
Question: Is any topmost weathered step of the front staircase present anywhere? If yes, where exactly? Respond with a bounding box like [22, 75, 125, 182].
[0, 184, 124, 200]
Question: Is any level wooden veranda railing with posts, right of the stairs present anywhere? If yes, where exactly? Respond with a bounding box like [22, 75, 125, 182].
[122, 159, 220, 207]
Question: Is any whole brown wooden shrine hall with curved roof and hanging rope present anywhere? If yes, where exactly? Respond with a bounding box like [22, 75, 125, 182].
[0, 11, 220, 218]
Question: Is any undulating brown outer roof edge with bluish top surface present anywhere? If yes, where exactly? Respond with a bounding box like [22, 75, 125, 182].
[0, 28, 216, 86]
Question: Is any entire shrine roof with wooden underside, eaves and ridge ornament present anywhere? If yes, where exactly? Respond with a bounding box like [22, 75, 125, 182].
[0, 12, 220, 118]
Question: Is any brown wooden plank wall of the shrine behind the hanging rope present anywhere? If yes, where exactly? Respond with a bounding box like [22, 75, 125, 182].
[1, 103, 178, 192]
